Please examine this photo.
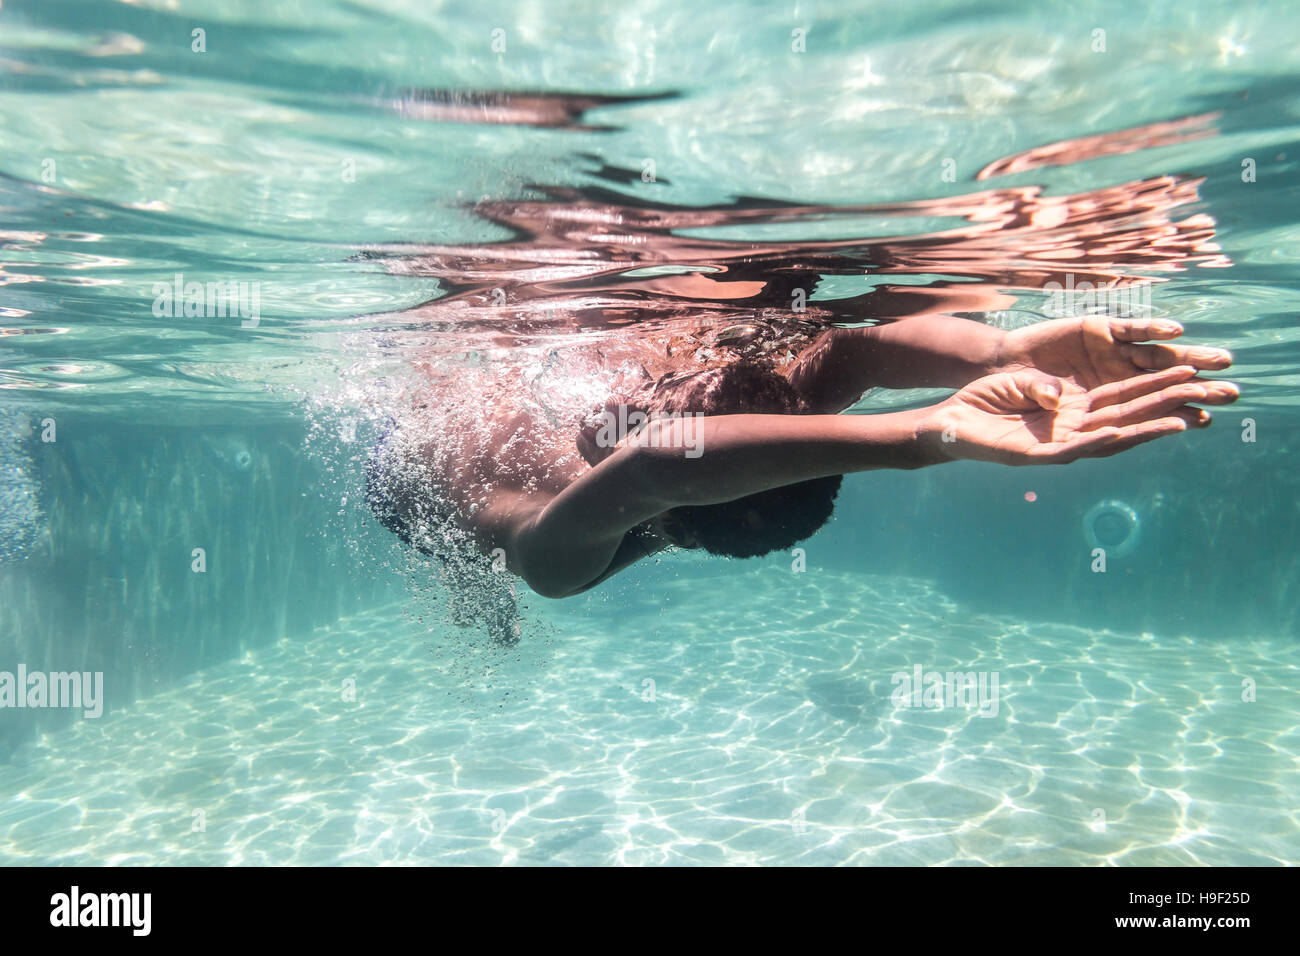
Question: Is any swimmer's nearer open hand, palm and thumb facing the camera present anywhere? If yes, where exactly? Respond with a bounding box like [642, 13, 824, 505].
[917, 365, 1238, 464]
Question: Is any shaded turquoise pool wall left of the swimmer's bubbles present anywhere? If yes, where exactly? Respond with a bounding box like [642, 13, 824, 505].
[0, 414, 400, 758]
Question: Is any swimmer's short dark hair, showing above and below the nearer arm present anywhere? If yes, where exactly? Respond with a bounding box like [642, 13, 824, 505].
[638, 362, 844, 558]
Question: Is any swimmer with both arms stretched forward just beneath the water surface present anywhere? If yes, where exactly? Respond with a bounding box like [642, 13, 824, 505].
[368, 315, 1238, 598]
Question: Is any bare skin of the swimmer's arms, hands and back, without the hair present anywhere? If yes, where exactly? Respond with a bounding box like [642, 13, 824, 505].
[405, 315, 1239, 597]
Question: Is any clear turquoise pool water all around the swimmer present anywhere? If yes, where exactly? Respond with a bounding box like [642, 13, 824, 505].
[0, 0, 1300, 865]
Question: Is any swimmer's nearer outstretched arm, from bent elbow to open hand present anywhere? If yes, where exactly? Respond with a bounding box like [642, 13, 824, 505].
[493, 365, 1235, 597]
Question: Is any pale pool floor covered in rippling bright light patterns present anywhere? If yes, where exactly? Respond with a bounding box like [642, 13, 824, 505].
[0, 566, 1300, 865]
